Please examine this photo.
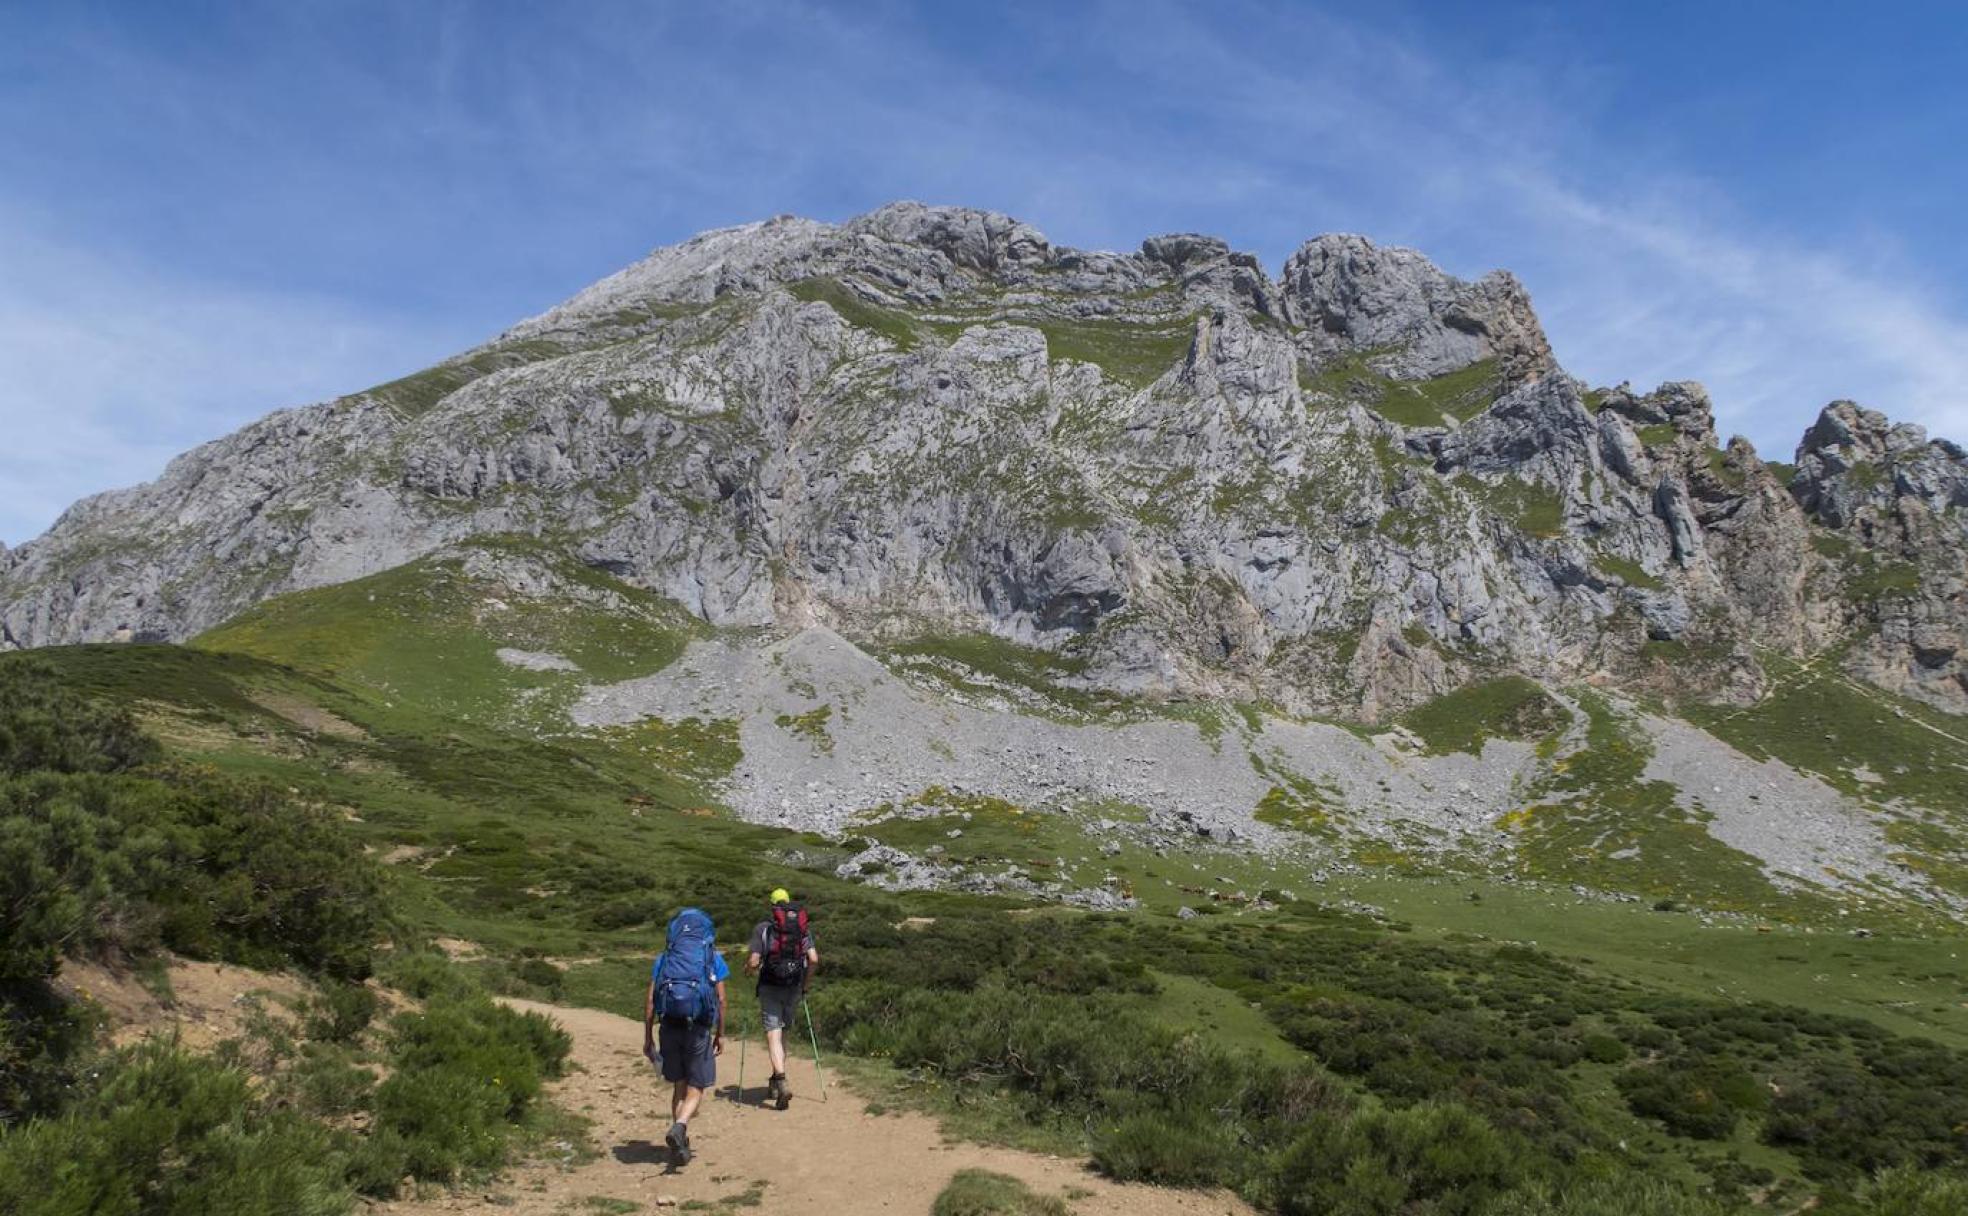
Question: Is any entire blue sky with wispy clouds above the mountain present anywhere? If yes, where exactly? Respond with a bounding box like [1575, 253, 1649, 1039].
[0, 0, 1968, 543]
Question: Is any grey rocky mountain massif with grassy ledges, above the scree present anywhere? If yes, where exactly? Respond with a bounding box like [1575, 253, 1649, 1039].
[0, 203, 1968, 708]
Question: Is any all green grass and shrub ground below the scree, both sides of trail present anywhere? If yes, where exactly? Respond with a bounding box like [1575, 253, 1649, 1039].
[0, 554, 1968, 1216]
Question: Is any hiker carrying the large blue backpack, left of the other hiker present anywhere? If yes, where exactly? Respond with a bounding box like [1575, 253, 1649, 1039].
[642, 907, 732, 1165]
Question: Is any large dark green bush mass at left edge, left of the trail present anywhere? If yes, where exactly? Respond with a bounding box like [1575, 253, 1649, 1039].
[0, 655, 382, 1125]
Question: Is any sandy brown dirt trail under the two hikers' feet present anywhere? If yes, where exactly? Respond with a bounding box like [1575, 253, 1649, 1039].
[372, 1002, 1252, 1216]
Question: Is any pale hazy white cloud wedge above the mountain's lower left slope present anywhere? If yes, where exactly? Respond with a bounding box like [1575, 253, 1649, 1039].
[0, 213, 464, 543]
